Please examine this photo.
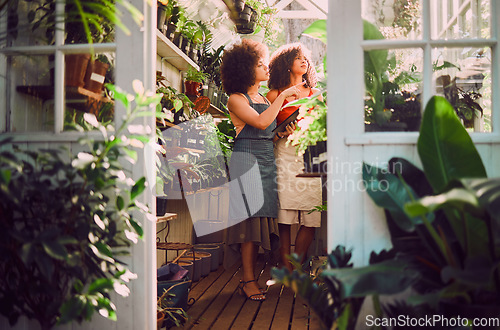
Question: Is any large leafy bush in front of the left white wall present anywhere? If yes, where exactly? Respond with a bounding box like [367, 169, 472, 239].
[0, 83, 160, 330]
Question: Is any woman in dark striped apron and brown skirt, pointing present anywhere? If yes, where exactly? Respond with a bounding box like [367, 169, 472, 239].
[221, 39, 300, 301]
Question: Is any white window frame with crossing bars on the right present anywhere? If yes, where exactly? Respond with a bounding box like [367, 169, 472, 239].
[328, 0, 500, 145]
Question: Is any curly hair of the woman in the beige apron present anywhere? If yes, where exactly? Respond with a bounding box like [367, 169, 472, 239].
[267, 42, 318, 90]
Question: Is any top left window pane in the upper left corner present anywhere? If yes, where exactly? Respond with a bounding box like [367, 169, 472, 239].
[0, 0, 55, 48]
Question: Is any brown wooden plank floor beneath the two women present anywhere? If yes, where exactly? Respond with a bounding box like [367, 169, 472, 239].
[173, 261, 321, 330]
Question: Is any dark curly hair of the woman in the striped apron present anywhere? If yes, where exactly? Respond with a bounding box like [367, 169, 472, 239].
[220, 39, 268, 94]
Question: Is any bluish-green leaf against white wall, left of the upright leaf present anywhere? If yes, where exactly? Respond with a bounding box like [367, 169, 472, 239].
[363, 163, 422, 232]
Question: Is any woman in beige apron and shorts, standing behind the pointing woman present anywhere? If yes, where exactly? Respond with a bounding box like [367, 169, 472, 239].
[267, 43, 322, 270]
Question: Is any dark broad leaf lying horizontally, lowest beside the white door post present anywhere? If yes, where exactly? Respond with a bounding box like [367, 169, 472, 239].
[321, 259, 420, 298]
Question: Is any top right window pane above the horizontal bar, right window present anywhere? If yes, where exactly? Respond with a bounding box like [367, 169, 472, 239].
[431, 0, 491, 39]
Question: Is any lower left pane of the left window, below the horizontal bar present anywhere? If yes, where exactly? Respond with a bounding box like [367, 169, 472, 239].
[8, 55, 54, 132]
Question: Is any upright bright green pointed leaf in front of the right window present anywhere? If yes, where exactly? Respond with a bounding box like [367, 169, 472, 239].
[417, 96, 486, 193]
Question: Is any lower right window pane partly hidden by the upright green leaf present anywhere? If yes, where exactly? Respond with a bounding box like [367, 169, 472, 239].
[432, 48, 491, 132]
